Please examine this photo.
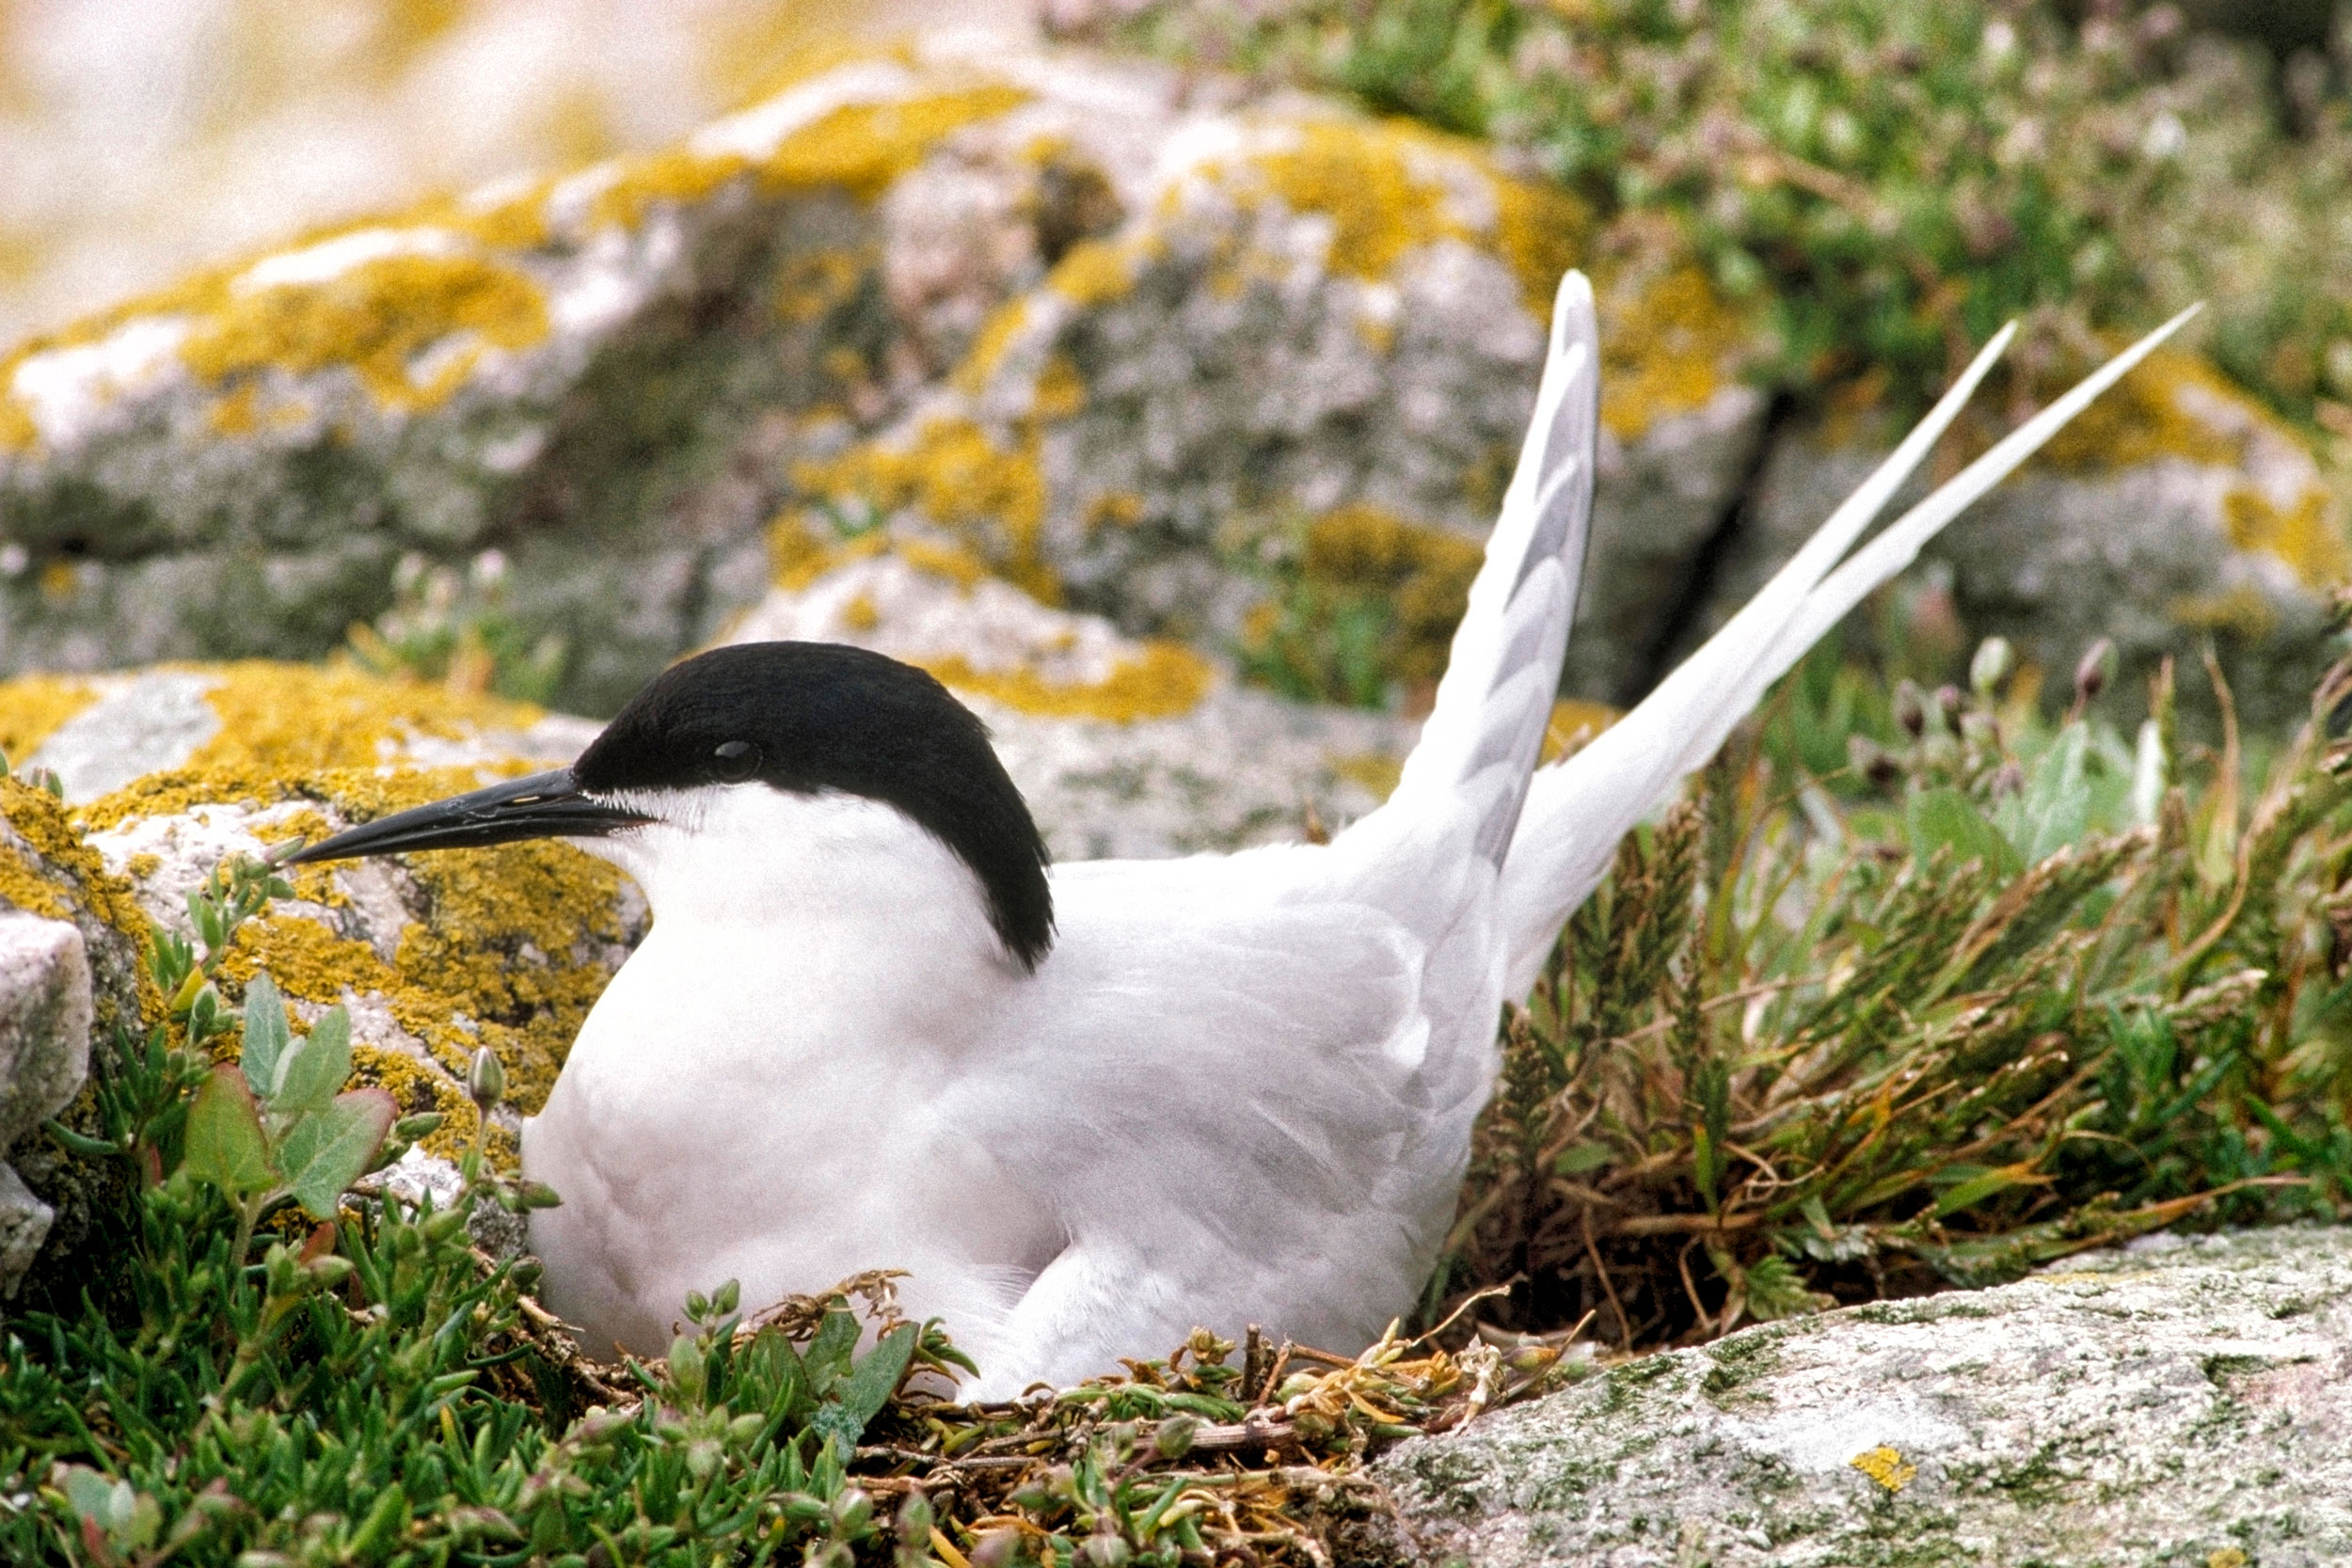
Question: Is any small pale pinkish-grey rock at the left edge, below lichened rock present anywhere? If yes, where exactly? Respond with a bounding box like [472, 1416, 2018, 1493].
[0, 912, 89, 1295]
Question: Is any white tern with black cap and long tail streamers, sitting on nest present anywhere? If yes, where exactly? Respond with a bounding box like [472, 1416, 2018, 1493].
[290, 273, 2185, 1397]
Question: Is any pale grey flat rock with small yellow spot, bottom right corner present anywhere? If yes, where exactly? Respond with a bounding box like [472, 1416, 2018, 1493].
[1378, 1229, 2352, 1568]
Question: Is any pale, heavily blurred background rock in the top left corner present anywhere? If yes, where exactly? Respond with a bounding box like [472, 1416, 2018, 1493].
[0, 0, 1030, 341]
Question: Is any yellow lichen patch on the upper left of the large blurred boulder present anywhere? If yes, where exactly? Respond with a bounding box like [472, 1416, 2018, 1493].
[182, 256, 548, 409]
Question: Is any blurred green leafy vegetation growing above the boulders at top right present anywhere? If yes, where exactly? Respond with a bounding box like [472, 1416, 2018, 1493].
[1089, 0, 2352, 433]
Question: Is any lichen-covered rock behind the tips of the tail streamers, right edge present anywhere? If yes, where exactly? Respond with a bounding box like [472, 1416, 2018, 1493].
[1708, 353, 2352, 724]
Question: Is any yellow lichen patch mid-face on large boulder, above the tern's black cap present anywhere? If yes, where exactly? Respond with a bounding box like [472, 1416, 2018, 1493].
[793, 416, 1061, 604]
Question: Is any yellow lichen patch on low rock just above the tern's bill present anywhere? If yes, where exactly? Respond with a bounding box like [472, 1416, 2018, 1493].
[188, 658, 541, 771]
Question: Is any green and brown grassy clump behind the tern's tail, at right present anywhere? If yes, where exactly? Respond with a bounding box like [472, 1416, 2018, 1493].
[1433, 615, 2352, 1347]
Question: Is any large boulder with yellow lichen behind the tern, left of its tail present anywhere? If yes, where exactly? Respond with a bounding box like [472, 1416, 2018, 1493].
[0, 44, 1757, 712]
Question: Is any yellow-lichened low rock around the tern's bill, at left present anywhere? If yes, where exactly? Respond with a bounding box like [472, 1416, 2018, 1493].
[0, 663, 647, 1289]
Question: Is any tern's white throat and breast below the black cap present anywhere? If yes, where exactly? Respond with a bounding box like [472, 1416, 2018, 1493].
[522, 785, 1061, 1354]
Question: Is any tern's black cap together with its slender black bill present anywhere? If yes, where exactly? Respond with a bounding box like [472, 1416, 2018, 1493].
[290, 641, 1054, 969]
